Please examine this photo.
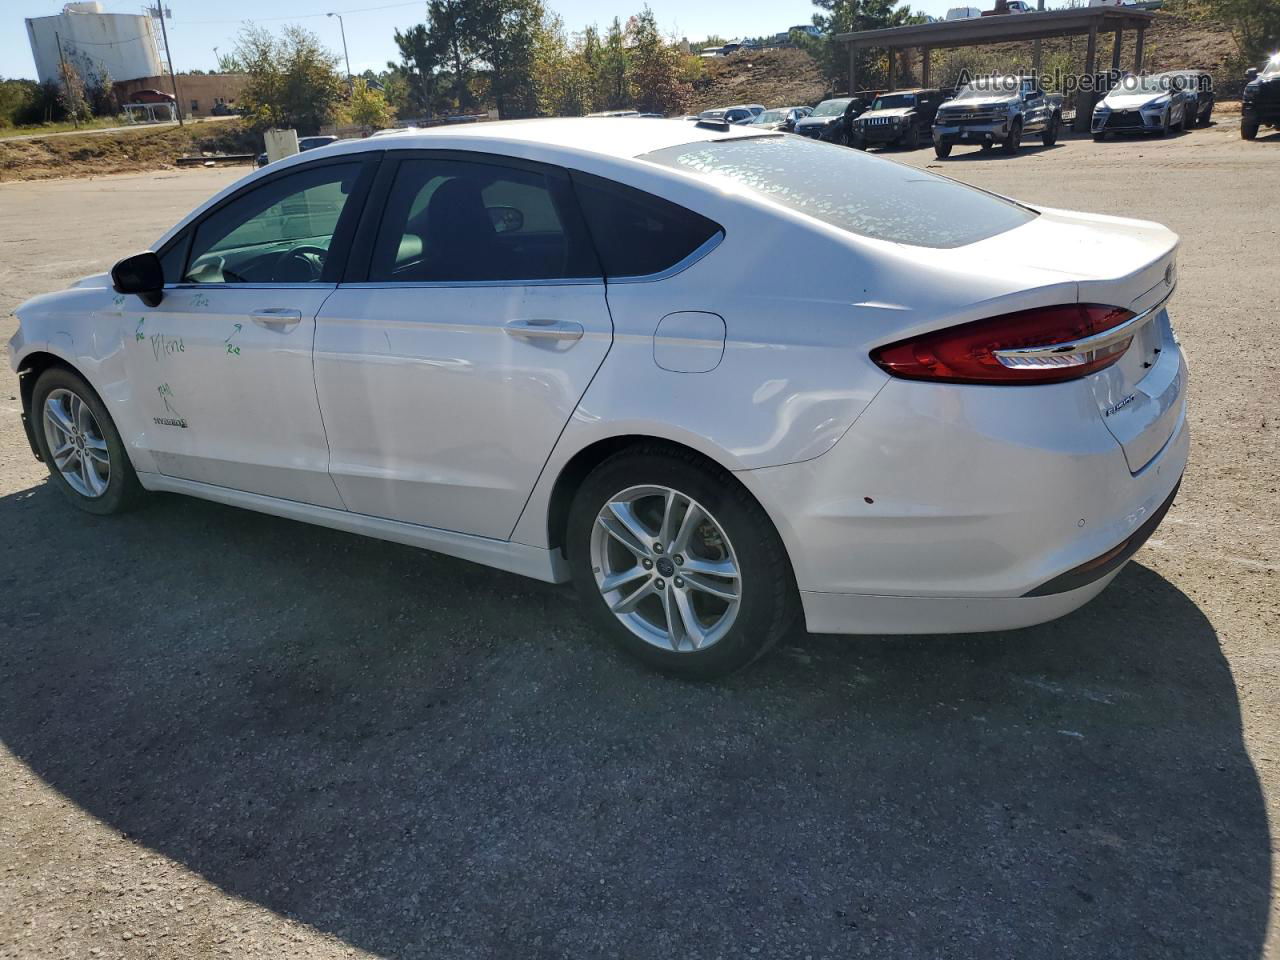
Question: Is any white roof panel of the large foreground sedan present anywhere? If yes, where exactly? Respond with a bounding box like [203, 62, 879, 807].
[317, 116, 760, 159]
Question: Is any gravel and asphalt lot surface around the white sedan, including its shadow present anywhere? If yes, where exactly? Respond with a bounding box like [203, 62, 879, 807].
[0, 120, 1280, 960]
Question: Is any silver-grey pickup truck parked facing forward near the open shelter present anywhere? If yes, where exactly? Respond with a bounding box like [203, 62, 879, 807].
[933, 77, 1062, 160]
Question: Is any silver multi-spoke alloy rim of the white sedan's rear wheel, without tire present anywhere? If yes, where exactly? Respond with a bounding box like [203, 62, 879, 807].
[590, 485, 742, 653]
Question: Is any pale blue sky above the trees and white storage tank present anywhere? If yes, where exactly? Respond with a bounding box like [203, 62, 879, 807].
[0, 0, 959, 77]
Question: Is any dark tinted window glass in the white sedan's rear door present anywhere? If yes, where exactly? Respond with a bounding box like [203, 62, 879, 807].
[369, 157, 600, 283]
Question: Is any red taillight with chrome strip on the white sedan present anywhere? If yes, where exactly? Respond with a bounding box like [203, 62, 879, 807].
[872, 303, 1134, 384]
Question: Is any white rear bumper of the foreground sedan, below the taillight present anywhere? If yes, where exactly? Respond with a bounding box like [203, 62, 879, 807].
[739, 356, 1190, 634]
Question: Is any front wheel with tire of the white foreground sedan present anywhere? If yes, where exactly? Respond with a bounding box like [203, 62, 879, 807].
[31, 367, 142, 515]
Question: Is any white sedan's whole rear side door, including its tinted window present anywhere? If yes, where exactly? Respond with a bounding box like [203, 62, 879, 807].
[315, 151, 613, 538]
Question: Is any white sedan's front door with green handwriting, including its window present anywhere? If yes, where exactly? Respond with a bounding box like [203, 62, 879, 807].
[125, 155, 376, 508]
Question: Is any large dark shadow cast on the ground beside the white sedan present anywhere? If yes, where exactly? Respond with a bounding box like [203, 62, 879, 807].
[0, 485, 1271, 960]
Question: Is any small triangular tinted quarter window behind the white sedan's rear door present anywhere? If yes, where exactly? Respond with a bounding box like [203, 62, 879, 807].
[571, 172, 723, 278]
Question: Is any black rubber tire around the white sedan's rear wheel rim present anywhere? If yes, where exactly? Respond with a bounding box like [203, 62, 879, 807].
[566, 444, 799, 680]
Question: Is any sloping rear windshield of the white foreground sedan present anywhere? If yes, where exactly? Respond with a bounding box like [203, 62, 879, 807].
[639, 137, 1037, 248]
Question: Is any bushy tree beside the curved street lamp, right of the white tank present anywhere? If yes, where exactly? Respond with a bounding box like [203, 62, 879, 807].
[234, 23, 347, 134]
